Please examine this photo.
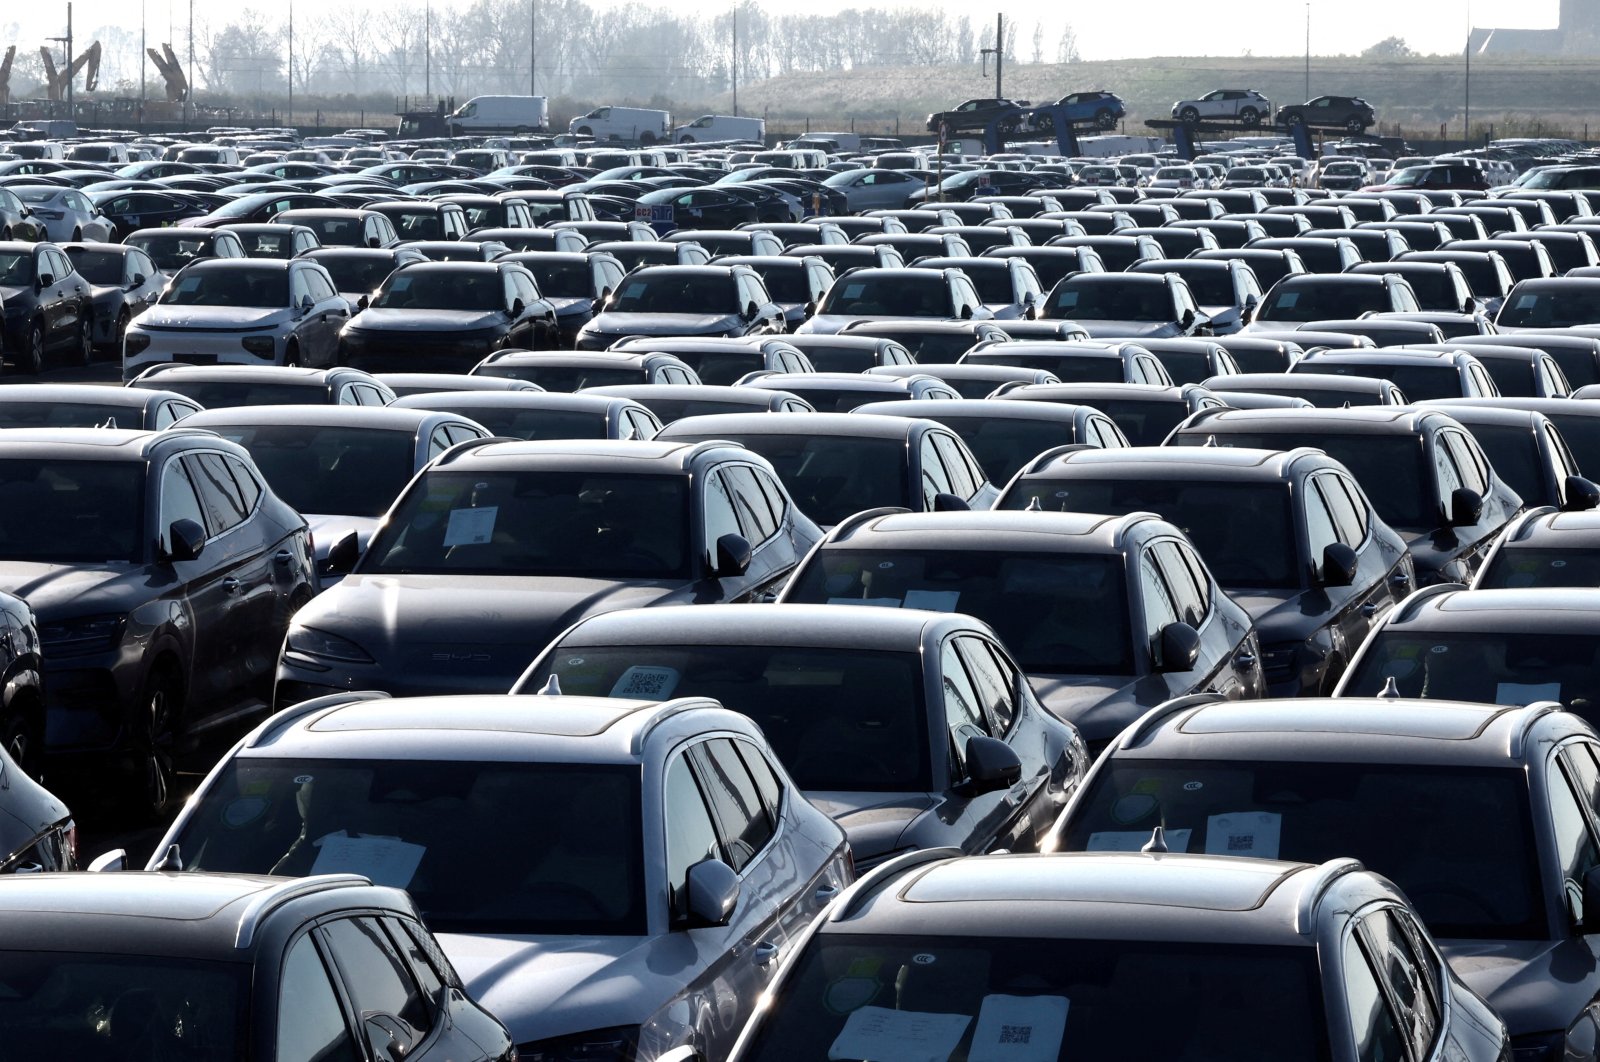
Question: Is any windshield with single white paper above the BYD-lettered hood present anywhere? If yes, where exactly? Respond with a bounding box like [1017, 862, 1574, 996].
[362, 469, 690, 579]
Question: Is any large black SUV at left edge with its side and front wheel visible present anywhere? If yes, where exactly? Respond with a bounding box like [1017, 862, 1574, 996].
[0, 427, 317, 814]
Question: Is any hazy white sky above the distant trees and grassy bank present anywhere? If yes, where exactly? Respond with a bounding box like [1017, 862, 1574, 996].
[0, 0, 1558, 59]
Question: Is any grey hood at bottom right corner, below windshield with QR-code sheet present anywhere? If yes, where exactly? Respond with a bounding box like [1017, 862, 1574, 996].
[1438, 937, 1600, 1036]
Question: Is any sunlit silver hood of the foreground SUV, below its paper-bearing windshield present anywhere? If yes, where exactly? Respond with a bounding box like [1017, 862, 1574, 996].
[437, 932, 668, 1043]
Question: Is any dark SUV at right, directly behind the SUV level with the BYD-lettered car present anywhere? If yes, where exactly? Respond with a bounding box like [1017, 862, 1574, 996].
[1171, 406, 1522, 585]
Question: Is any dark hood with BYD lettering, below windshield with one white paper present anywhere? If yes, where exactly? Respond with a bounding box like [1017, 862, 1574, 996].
[294, 574, 688, 693]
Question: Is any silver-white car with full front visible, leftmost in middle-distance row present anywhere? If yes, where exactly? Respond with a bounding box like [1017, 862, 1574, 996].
[122, 259, 350, 379]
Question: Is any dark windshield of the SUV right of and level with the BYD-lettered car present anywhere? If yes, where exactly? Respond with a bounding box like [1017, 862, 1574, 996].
[1000, 475, 1306, 590]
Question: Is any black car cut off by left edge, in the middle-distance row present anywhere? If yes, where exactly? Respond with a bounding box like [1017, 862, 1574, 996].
[0, 242, 94, 373]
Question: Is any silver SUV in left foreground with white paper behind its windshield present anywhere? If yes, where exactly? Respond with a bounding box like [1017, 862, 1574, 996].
[147, 687, 853, 1062]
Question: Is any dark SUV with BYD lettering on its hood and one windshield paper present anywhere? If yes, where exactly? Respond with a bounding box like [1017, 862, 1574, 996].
[275, 435, 821, 707]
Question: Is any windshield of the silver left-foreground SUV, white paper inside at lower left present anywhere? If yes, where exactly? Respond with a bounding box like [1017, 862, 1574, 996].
[178, 757, 645, 936]
